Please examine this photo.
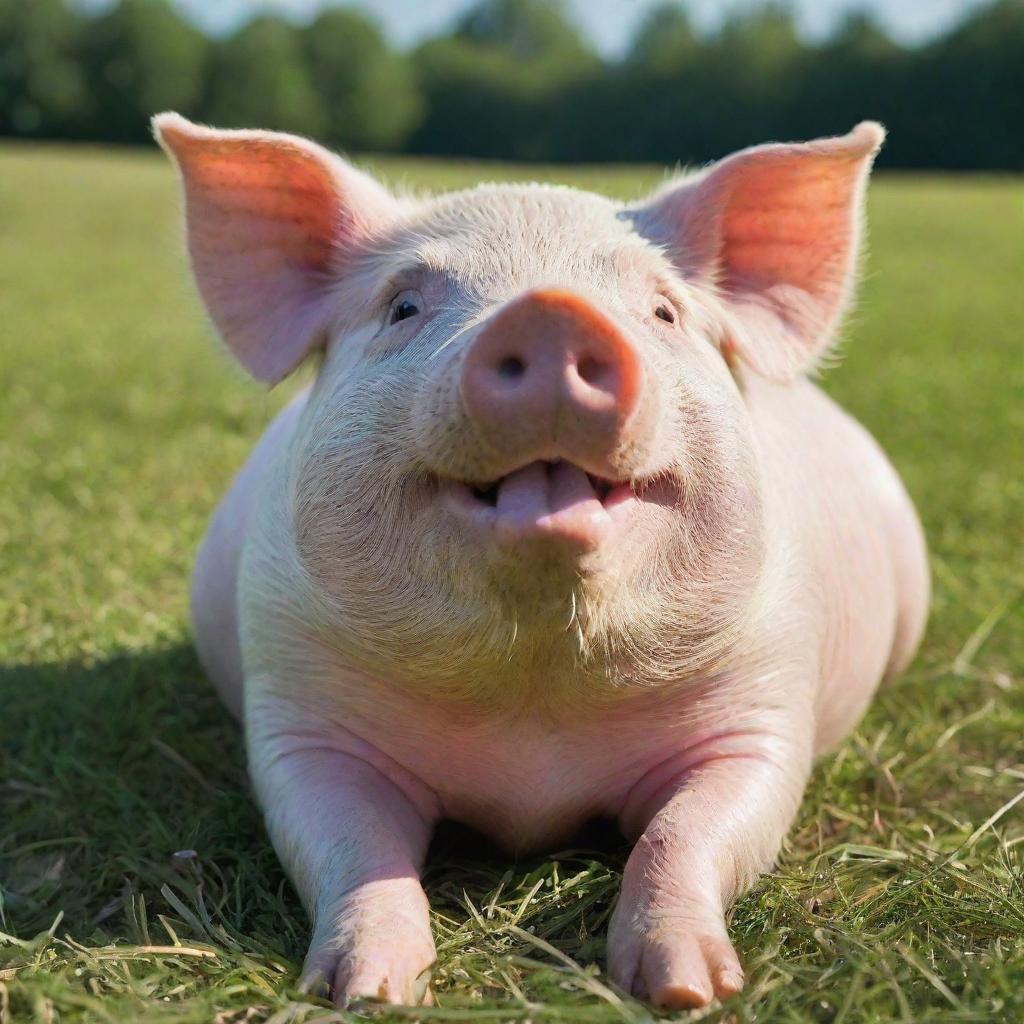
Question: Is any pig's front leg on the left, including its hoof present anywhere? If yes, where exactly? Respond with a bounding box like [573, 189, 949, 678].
[247, 705, 436, 1004]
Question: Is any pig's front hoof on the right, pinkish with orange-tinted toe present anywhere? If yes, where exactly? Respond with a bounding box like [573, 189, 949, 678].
[609, 926, 743, 1010]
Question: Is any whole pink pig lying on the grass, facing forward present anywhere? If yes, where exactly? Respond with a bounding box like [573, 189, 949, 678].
[154, 113, 929, 1009]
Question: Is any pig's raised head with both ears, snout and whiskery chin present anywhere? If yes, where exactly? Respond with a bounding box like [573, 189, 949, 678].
[156, 115, 883, 696]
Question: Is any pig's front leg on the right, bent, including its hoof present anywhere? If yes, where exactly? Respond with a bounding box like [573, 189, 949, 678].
[608, 723, 811, 1010]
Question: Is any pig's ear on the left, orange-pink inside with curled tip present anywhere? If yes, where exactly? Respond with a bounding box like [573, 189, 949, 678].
[153, 114, 397, 383]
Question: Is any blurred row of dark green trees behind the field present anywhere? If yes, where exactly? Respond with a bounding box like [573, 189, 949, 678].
[0, 0, 1024, 170]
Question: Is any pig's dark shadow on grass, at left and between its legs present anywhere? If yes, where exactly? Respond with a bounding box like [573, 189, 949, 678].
[0, 643, 626, 962]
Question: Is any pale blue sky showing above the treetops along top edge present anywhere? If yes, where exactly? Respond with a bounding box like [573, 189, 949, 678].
[81, 0, 995, 56]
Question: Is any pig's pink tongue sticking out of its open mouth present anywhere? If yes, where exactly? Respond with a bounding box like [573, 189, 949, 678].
[497, 462, 609, 550]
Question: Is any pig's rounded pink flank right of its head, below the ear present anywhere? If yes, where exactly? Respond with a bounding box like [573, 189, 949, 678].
[748, 380, 929, 752]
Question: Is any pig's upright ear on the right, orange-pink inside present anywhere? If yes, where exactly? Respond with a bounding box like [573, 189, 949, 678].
[635, 121, 885, 381]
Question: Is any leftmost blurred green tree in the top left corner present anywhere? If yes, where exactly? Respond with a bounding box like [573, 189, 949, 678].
[0, 0, 85, 137]
